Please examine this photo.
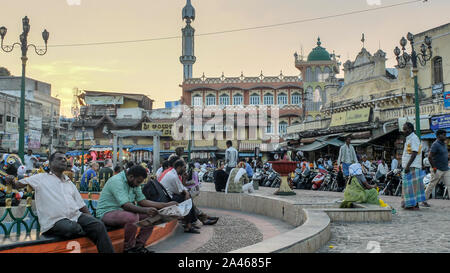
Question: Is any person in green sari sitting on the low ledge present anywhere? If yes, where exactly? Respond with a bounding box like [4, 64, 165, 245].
[340, 163, 380, 208]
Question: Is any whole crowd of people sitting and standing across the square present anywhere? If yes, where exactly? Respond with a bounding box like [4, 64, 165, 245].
[1, 122, 450, 253]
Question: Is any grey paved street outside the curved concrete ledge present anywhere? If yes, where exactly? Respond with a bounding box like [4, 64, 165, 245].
[203, 184, 450, 253]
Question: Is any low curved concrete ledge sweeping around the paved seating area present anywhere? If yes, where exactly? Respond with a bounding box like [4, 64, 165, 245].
[194, 191, 392, 253]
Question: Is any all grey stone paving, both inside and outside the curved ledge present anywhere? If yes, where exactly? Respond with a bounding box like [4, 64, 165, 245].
[156, 183, 450, 253]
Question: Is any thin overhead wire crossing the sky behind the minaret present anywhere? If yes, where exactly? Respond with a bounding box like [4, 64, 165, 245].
[48, 0, 426, 48]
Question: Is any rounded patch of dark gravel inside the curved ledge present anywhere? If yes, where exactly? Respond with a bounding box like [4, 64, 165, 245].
[193, 215, 263, 253]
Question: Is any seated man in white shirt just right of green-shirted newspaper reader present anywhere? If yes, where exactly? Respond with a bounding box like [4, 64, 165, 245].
[160, 159, 200, 234]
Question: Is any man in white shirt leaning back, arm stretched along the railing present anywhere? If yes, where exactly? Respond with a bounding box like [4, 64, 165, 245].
[7, 152, 114, 253]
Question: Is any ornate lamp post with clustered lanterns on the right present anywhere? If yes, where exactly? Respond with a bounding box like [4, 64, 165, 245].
[394, 32, 433, 139]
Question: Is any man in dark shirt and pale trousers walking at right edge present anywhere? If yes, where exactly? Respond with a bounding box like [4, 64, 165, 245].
[423, 129, 450, 207]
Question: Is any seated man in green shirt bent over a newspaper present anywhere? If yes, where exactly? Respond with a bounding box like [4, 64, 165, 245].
[97, 166, 177, 253]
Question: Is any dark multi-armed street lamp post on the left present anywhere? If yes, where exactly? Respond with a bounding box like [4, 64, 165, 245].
[0, 16, 49, 161]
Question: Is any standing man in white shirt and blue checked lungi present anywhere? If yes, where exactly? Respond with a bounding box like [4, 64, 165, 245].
[402, 122, 425, 210]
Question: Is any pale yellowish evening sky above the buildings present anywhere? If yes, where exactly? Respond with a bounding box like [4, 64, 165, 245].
[0, 0, 450, 116]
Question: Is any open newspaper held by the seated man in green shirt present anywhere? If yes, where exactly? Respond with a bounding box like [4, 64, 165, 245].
[136, 199, 192, 228]
